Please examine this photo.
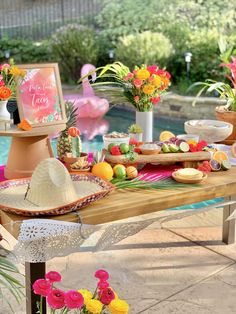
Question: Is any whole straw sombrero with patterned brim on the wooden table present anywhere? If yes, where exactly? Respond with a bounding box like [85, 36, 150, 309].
[0, 158, 113, 216]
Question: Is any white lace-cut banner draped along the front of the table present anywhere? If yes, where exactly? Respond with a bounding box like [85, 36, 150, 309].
[13, 201, 236, 263]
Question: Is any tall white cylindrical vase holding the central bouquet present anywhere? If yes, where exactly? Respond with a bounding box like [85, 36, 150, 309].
[136, 111, 153, 142]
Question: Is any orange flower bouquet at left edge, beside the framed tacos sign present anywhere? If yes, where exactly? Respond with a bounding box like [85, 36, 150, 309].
[0, 62, 26, 101]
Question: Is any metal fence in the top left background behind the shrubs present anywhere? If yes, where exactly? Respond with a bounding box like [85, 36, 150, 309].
[0, 0, 102, 40]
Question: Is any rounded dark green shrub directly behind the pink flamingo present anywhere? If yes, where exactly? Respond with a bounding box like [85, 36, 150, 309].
[51, 24, 98, 82]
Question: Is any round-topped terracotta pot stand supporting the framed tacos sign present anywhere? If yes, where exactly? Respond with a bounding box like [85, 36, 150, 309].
[0, 123, 66, 179]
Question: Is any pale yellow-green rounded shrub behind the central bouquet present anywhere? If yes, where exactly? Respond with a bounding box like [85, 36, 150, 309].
[116, 31, 172, 68]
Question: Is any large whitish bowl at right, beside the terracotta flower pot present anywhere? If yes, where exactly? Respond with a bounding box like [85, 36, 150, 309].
[184, 120, 233, 143]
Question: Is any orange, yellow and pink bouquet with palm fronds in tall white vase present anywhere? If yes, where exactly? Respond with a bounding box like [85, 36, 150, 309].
[82, 62, 171, 111]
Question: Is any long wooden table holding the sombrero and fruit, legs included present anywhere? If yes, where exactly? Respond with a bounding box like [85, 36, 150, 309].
[1, 168, 236, 314]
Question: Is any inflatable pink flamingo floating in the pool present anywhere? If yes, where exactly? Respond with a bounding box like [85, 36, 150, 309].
[64, 64, 109, 118]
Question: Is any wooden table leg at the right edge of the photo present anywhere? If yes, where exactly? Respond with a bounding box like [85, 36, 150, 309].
[222, 195, 236, 244]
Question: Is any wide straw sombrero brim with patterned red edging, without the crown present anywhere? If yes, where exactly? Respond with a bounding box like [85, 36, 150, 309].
[0, 173, 114, 216]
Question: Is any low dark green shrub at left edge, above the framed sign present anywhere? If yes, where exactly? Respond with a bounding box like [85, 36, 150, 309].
[0, 37, 51, 64]
